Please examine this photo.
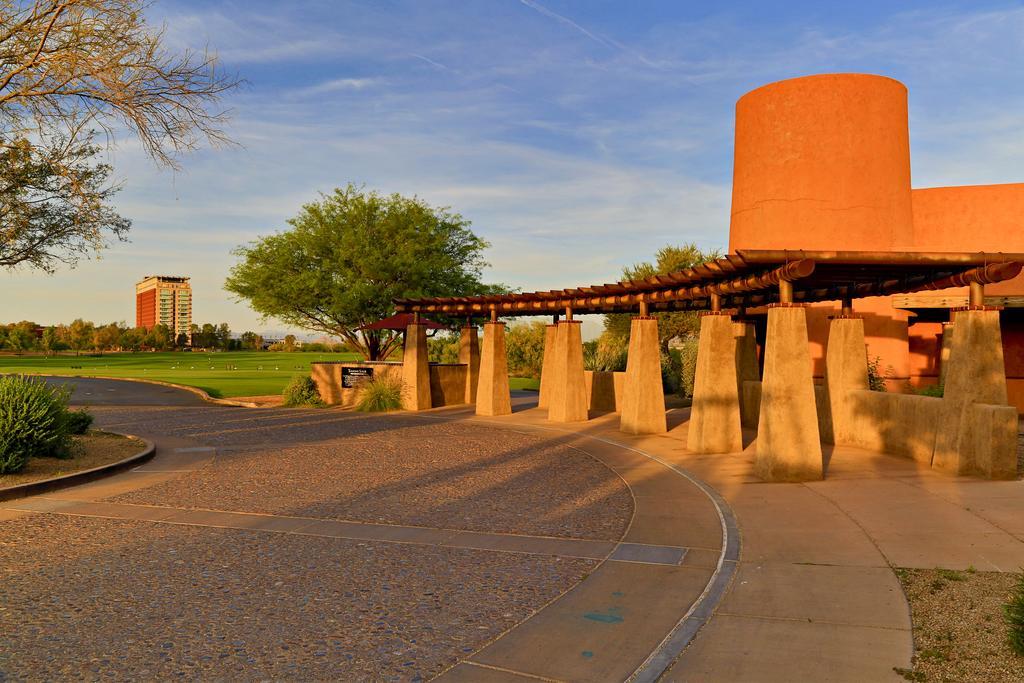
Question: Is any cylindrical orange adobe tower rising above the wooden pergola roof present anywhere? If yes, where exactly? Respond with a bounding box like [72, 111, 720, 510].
[729, 74, 913, 252]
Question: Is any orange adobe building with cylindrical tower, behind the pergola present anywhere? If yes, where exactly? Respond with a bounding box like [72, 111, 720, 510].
[729, 74, 1024, 413]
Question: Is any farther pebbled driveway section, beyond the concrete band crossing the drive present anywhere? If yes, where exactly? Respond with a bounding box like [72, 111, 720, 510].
[103, 409, 633, 540]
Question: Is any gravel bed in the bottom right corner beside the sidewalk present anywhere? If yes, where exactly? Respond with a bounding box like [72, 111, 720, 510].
[896, 569, 1024, 683]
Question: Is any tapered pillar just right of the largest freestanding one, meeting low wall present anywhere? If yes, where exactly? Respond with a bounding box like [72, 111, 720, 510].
[825, 317, 870, 445]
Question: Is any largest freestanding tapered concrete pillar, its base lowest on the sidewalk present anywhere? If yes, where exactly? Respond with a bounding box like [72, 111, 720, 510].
[755, 305, 824, 481]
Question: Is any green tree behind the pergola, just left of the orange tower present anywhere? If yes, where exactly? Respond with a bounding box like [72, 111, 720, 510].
[604, 243, 722, 352]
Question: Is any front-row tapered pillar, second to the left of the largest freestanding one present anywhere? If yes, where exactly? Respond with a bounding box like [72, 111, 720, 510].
[618, 315, 668, 434]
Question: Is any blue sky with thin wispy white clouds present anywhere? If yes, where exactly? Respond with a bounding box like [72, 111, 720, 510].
[0, 0, 1024, 331]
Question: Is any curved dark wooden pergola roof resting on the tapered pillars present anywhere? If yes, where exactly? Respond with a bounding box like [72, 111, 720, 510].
[394, 249, 1024, 316]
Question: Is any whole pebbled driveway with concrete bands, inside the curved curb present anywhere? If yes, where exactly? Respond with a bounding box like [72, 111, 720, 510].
[0, 381, 737, 680]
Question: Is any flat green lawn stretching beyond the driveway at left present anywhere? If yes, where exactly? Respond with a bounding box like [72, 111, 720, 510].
[0, 351, 540, 398]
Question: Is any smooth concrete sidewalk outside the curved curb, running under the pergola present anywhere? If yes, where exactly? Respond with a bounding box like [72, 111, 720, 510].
[413, 403, 1024, 681]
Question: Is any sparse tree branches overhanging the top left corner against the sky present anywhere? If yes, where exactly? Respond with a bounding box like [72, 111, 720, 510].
[0, 0, 239, 270]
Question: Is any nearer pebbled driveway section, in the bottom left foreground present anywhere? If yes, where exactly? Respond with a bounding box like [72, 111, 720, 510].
[0, 515, 595, 681]
